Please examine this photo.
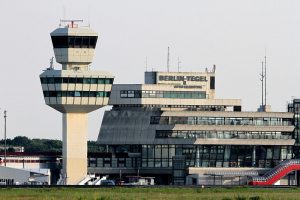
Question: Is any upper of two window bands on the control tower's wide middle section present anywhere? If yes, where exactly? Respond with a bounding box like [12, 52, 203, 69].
[40, 77, 114, 84]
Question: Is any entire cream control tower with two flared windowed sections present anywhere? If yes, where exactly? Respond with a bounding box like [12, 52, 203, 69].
[40, 20, 114, 185]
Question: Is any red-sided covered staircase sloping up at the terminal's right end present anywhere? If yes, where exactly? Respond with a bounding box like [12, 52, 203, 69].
[248, 159, 300, 186]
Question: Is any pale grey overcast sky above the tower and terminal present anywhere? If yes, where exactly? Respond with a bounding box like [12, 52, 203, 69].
[0, 0, 300, 140]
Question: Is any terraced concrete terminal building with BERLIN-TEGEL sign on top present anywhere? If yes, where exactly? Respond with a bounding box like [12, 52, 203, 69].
[92, 66, 299, 185]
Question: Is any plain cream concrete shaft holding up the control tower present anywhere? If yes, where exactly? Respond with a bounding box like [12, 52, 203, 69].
[63, 113, 87, 185]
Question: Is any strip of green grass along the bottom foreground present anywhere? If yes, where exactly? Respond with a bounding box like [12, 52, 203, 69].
[0, 187, 300, 200]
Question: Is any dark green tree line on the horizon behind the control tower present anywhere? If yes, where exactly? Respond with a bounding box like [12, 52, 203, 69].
[0, 136, 99, 153]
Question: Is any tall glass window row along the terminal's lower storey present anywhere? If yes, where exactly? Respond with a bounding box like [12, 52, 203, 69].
[142, 145, 292, 168]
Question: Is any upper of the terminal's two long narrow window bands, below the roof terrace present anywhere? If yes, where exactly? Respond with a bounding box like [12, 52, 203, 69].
[150, 116, 292, 126]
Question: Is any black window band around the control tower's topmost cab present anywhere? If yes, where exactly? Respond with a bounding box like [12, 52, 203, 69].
[51, 36, 98, 49]
